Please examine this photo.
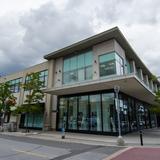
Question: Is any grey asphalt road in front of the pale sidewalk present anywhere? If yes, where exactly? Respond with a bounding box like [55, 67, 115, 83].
[0, 135, 123, 160]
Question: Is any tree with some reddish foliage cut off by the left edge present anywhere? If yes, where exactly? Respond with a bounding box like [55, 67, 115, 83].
[0, 82, 16, 125]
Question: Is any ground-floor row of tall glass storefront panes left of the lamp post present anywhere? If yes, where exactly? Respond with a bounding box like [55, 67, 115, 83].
[58, 93, 117, 133]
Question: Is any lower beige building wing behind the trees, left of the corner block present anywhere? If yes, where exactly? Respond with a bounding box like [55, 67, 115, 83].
[0, 62, 50, 129]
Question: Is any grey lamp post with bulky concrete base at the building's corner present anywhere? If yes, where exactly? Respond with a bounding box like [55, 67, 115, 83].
[114, 85, 125, 146]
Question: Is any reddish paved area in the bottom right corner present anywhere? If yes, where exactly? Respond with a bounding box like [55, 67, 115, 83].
[104, 147, 160, 160]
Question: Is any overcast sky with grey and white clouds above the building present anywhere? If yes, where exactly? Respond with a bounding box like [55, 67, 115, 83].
[0, 0, 160, 75]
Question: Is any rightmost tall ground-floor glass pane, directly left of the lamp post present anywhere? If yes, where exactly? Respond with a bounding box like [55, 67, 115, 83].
[102, 93, 116, 132]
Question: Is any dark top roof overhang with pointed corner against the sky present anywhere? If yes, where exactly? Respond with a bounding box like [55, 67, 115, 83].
[44, 27, 159, 83]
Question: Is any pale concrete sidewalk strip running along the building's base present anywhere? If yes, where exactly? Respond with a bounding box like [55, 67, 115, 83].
[0, 129, 160, 147]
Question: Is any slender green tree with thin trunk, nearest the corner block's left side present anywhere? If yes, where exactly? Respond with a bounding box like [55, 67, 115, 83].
[14, 73, 44, 132]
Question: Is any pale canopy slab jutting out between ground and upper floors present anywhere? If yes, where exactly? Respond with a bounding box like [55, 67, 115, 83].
[44, 75, 155, 104]
